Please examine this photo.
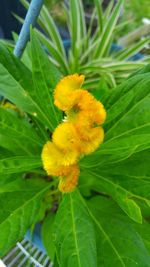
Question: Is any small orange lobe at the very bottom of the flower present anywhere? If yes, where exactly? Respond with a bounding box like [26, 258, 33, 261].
[58, 165, 80, 193]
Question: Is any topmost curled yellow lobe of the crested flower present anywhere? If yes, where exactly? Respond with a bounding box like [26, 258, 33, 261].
[54, 74, 84, 111]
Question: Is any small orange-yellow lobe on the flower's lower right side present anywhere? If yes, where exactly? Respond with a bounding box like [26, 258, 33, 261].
[81, 127, 104, 155]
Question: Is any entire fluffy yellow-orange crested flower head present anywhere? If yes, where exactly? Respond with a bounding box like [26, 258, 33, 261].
[42, 74, 106, 192]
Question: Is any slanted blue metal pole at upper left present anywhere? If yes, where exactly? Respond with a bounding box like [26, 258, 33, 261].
[14, 0, 44, 58]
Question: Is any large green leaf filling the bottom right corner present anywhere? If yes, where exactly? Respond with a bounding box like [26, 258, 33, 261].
[88, 196, 150, 267]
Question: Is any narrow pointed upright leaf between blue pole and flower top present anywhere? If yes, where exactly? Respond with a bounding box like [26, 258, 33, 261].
[31, 30, 62, 129]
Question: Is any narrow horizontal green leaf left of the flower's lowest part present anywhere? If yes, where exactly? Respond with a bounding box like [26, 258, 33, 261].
[0, 156, 42, 174]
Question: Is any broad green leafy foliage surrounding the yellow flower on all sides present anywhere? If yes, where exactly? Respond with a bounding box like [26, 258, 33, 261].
[0, 27, 150, 267]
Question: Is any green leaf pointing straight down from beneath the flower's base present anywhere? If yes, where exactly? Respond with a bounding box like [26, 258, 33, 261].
[54, 191, 97, 267]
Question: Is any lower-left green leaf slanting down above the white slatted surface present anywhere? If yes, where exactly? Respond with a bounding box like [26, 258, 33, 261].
[0, 180, 49, 257]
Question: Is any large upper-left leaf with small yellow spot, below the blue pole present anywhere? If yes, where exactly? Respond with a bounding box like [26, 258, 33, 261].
[0, 44, 60, 130]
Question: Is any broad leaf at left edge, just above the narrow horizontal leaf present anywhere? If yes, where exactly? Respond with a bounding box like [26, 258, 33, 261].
[0, 108, 43, 155]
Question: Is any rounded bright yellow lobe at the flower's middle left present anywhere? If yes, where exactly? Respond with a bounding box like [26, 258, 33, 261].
[52, 122, 80, 154]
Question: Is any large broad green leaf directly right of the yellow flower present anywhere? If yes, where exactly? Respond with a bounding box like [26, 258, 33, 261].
[82, 73, 150, 168]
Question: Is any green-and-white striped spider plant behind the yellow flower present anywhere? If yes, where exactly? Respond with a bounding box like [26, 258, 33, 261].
[13, 0, 149, 88]
